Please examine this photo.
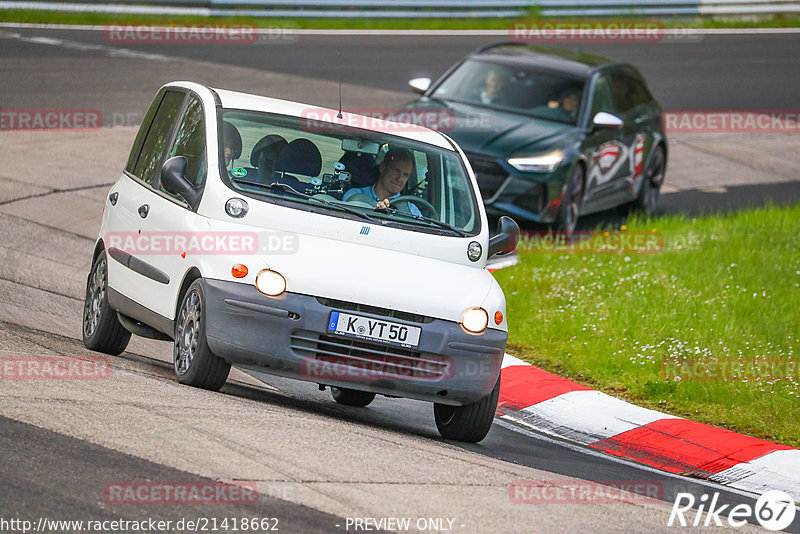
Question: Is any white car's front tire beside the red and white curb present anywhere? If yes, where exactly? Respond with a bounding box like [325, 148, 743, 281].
[433, 376, 500, 443]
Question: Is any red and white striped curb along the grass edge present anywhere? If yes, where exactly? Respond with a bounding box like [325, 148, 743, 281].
[497, 354, 800, 502]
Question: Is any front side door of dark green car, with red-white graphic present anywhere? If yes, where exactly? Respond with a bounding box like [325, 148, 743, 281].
[583, 70, 636, 212]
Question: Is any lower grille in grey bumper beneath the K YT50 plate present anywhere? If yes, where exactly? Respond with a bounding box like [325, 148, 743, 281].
[290, 330, 450, 380]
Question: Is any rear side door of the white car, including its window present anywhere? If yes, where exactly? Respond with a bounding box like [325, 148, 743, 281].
[103, 90, 186, 320]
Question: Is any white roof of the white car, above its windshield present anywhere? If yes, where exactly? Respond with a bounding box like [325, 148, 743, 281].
[206, 85, 454, 151]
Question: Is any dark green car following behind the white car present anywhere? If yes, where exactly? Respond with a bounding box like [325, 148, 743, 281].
[406, 44, 667, 231]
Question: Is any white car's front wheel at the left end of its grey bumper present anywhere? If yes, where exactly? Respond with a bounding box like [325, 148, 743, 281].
[172, 279, 231, 391]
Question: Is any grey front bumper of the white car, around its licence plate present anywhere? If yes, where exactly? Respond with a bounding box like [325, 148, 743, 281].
[203, 279, 508, 405]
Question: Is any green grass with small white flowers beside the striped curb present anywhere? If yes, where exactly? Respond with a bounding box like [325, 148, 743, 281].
[495, 205, 800, 446]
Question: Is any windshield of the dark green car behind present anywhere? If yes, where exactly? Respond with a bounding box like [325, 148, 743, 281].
[432, 59, 584, 125]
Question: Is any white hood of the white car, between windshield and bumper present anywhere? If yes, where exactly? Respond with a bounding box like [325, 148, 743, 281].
[199, 215, 496, 321]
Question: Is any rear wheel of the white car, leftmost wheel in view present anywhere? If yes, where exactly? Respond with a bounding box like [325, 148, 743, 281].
[81, 251, 131, 356]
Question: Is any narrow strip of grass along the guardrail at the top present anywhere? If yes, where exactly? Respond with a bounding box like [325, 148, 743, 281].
[0, 8, 800, 30]
